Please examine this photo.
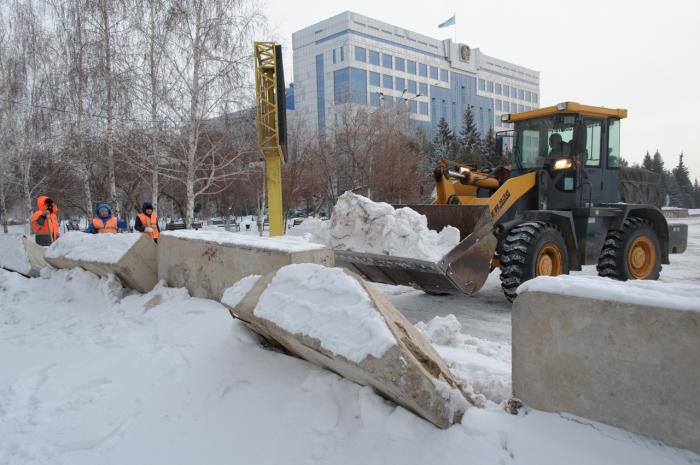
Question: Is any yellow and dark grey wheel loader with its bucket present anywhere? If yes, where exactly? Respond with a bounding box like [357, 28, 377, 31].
[336, 102, 688, 300]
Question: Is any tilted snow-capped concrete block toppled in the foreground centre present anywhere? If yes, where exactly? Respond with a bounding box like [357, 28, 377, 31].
[222, 263, 473, 428]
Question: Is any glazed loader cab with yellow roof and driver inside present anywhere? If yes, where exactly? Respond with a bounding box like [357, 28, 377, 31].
[503, 102, 627, 210]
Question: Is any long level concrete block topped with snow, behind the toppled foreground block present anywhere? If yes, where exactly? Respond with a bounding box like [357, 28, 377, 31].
[158, 230, 334, 300]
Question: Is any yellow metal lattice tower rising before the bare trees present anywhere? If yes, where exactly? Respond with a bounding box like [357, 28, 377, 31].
[253, 42, 286, 236]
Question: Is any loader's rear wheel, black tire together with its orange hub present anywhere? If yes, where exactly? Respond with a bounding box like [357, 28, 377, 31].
[597, 217, 661, 281]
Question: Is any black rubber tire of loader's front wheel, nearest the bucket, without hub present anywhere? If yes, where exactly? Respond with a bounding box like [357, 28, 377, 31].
[499, 221, 569, 302]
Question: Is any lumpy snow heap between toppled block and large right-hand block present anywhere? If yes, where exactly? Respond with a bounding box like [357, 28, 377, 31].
[415, 314, 512, 406]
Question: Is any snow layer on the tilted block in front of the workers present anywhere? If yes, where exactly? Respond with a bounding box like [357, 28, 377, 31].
[45, 231, 143, 263]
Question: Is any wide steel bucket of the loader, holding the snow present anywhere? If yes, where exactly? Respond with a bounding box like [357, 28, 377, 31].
[335, 205, 498, 294]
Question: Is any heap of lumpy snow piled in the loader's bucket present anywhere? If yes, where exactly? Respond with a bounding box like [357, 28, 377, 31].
[290, 191, 459, 262]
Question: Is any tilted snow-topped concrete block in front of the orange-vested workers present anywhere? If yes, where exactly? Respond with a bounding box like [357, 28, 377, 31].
[45, 231, 158, 292]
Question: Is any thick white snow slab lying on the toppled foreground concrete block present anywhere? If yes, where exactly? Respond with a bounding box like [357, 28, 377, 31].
[253, 263, 397, 363]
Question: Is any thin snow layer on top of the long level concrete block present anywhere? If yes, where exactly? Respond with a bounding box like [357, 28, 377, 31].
[161, 229, 324, 252]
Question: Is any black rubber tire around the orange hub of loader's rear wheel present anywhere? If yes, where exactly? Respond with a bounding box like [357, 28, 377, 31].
[596, 216, 661, 281]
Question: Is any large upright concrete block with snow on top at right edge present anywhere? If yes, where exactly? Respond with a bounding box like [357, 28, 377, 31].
[512, 276, 700, 453]
